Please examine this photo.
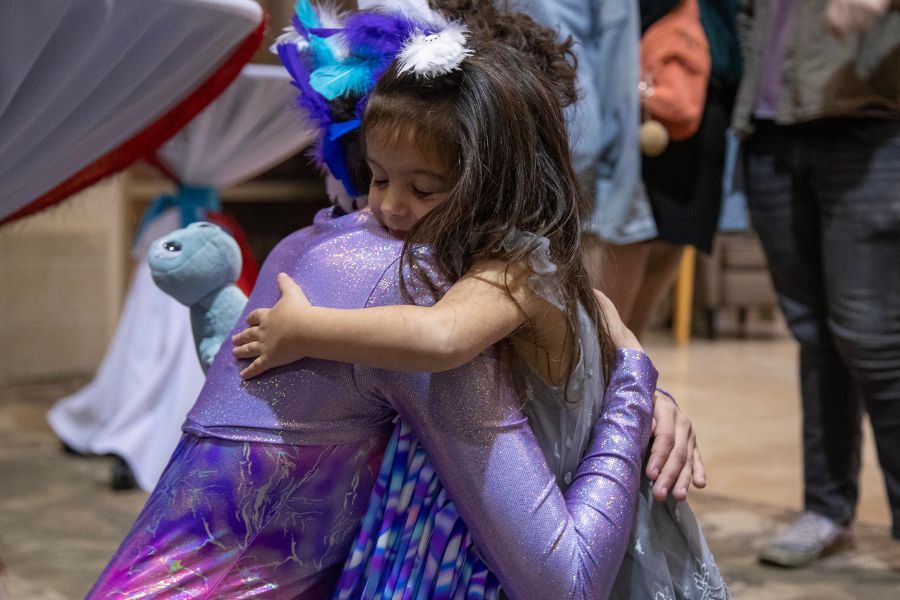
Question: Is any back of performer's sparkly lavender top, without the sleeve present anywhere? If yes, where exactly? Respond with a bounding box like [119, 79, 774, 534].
[184, 209, 402, 444]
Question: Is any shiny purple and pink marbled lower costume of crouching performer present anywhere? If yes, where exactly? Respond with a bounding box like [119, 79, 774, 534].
[87, 434, 385, 600]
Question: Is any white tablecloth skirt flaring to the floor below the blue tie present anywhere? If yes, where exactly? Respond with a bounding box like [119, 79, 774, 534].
[47, 210, 204, 491]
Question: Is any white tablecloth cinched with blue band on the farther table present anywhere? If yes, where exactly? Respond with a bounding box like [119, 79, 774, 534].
[49, 65, 313, 491]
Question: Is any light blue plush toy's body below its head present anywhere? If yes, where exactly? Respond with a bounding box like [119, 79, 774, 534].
[191, 284, 247, 373]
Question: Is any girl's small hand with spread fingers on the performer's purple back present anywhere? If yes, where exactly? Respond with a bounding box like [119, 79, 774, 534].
[231, 273, 311, 379]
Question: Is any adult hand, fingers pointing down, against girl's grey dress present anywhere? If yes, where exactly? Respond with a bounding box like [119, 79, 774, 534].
[646, 391, 706, 500]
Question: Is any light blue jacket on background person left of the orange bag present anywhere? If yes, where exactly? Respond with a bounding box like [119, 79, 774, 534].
[518, 0, 656, 244]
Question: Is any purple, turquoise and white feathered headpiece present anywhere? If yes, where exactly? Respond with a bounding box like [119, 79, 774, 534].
[272, 0, 472, 211]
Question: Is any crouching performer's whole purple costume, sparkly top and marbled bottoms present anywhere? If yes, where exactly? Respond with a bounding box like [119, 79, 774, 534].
[89, 211, 656, 599]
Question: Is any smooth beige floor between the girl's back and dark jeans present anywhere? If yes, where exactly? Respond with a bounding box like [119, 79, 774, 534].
[646, 334, 890, 525]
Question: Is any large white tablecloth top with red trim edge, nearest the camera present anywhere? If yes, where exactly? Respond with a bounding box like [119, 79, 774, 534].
[0, 0, 262, 220]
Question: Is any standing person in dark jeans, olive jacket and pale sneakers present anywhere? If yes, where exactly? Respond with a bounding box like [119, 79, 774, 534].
[734, 0, 900, 567]
